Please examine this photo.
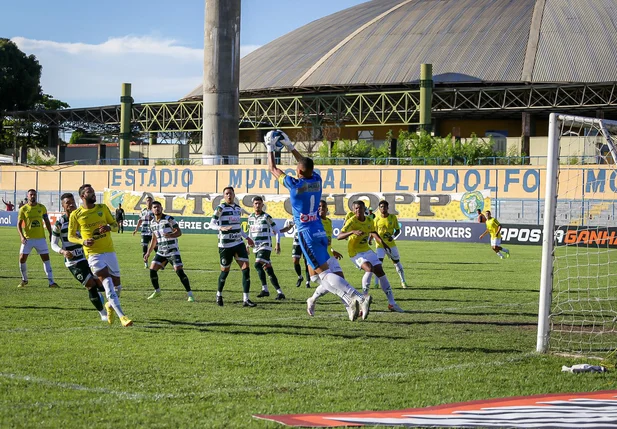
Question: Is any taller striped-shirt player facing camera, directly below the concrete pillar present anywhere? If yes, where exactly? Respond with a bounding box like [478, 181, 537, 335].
[210, 186, 256, 307]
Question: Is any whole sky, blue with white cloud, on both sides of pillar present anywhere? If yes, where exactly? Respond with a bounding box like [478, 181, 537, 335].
[0, 0, 366, 107]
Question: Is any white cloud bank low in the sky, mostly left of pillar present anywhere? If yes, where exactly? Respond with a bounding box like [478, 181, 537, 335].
[12, 36, 259, 107]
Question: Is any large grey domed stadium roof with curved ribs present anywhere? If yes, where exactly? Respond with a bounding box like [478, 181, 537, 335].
[186, 0, 617, 98]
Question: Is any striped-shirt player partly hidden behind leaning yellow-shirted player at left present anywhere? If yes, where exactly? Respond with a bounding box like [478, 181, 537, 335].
[51, 193, 107, 322]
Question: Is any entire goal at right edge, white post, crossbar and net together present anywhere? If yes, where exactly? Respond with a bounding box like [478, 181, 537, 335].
[537, 114, 617, 356]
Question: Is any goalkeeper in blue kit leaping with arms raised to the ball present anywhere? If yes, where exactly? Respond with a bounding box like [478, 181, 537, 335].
[265, 130, 372, 321]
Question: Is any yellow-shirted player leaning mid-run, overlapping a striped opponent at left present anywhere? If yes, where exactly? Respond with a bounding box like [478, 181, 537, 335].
[68, 184, 133, 326]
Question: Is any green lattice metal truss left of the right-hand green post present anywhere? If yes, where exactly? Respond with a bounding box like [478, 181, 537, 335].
[7, 90, 420, 133]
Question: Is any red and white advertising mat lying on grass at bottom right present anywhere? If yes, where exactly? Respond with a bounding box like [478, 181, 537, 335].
[253, 390, 617, 429]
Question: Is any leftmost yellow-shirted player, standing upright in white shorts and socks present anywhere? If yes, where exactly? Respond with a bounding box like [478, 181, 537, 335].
[17, 189, 59, 288]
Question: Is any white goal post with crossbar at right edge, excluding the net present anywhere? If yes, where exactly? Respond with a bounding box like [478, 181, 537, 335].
[536, 113, 617, 353]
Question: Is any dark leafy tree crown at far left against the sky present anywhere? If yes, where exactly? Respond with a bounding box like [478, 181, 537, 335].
[0, 38, 42, 112]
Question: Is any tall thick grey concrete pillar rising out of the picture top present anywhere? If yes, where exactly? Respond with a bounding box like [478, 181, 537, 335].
[203, 0, 240, 164]
